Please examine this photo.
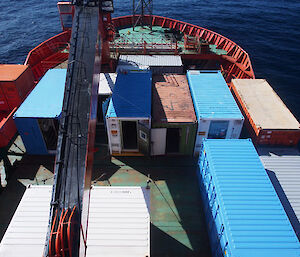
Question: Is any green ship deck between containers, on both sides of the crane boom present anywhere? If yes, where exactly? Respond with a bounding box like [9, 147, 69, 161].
[0, 130, 211, 254]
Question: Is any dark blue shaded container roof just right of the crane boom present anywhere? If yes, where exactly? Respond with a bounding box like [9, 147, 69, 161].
[106, 71, 152, 118]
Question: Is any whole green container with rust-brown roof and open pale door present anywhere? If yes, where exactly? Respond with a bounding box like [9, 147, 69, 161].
[151, 74, 197, 155]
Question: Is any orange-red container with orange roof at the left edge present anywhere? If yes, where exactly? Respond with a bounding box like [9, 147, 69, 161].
[0, 64, 34, 111]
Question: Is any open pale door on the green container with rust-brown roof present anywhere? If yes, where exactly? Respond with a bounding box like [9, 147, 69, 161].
[151, 128, 167, 155]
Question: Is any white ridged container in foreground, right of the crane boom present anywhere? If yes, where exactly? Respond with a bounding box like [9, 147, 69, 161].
[86, 186, 150, 257]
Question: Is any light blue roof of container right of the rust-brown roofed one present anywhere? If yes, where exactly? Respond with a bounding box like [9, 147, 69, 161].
[187, 70, 244, 119]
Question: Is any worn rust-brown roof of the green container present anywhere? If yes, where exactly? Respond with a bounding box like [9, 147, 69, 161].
[152, 74, 196, 124]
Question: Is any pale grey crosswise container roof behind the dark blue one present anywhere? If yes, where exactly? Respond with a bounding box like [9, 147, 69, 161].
[119, 55, 182, 67]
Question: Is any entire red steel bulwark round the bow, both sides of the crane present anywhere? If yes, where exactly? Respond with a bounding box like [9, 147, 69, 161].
[25, 8, 255, 82]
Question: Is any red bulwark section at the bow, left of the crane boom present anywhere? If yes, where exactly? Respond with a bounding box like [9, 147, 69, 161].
[25, 31, 71, 80]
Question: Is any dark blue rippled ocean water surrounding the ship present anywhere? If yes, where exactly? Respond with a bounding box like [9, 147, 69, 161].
[0, 0, 300, 120]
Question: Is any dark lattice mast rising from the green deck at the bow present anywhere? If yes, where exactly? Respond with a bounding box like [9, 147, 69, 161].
[132, 0, 153, 30]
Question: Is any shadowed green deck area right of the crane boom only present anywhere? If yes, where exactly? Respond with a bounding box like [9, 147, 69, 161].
[93, 132, 211, 256]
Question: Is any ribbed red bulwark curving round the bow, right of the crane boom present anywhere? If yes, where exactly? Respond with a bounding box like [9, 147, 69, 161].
[112, 15, 255, 79]
